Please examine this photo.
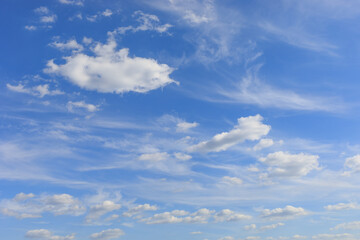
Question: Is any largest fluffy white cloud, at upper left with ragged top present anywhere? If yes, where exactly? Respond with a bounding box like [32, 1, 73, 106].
[44, 40, 177, 93]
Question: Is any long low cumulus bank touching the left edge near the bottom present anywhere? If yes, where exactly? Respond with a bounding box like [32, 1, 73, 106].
[0, 193, 86, 219]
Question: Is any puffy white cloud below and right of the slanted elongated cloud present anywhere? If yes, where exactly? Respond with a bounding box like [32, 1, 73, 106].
[259, 151, 320, 177]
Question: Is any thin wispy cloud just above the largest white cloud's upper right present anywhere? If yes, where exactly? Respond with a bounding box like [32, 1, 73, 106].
[109, 11, 172, 34]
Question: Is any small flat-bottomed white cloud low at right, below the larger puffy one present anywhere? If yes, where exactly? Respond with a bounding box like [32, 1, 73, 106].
[261, 205, 308, 220]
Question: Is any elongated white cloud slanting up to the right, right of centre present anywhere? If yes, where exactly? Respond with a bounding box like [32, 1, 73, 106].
[189, 115, 270, 153]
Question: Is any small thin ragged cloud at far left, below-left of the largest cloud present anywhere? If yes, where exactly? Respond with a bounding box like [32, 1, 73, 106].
[6, 84, 64, 98]
